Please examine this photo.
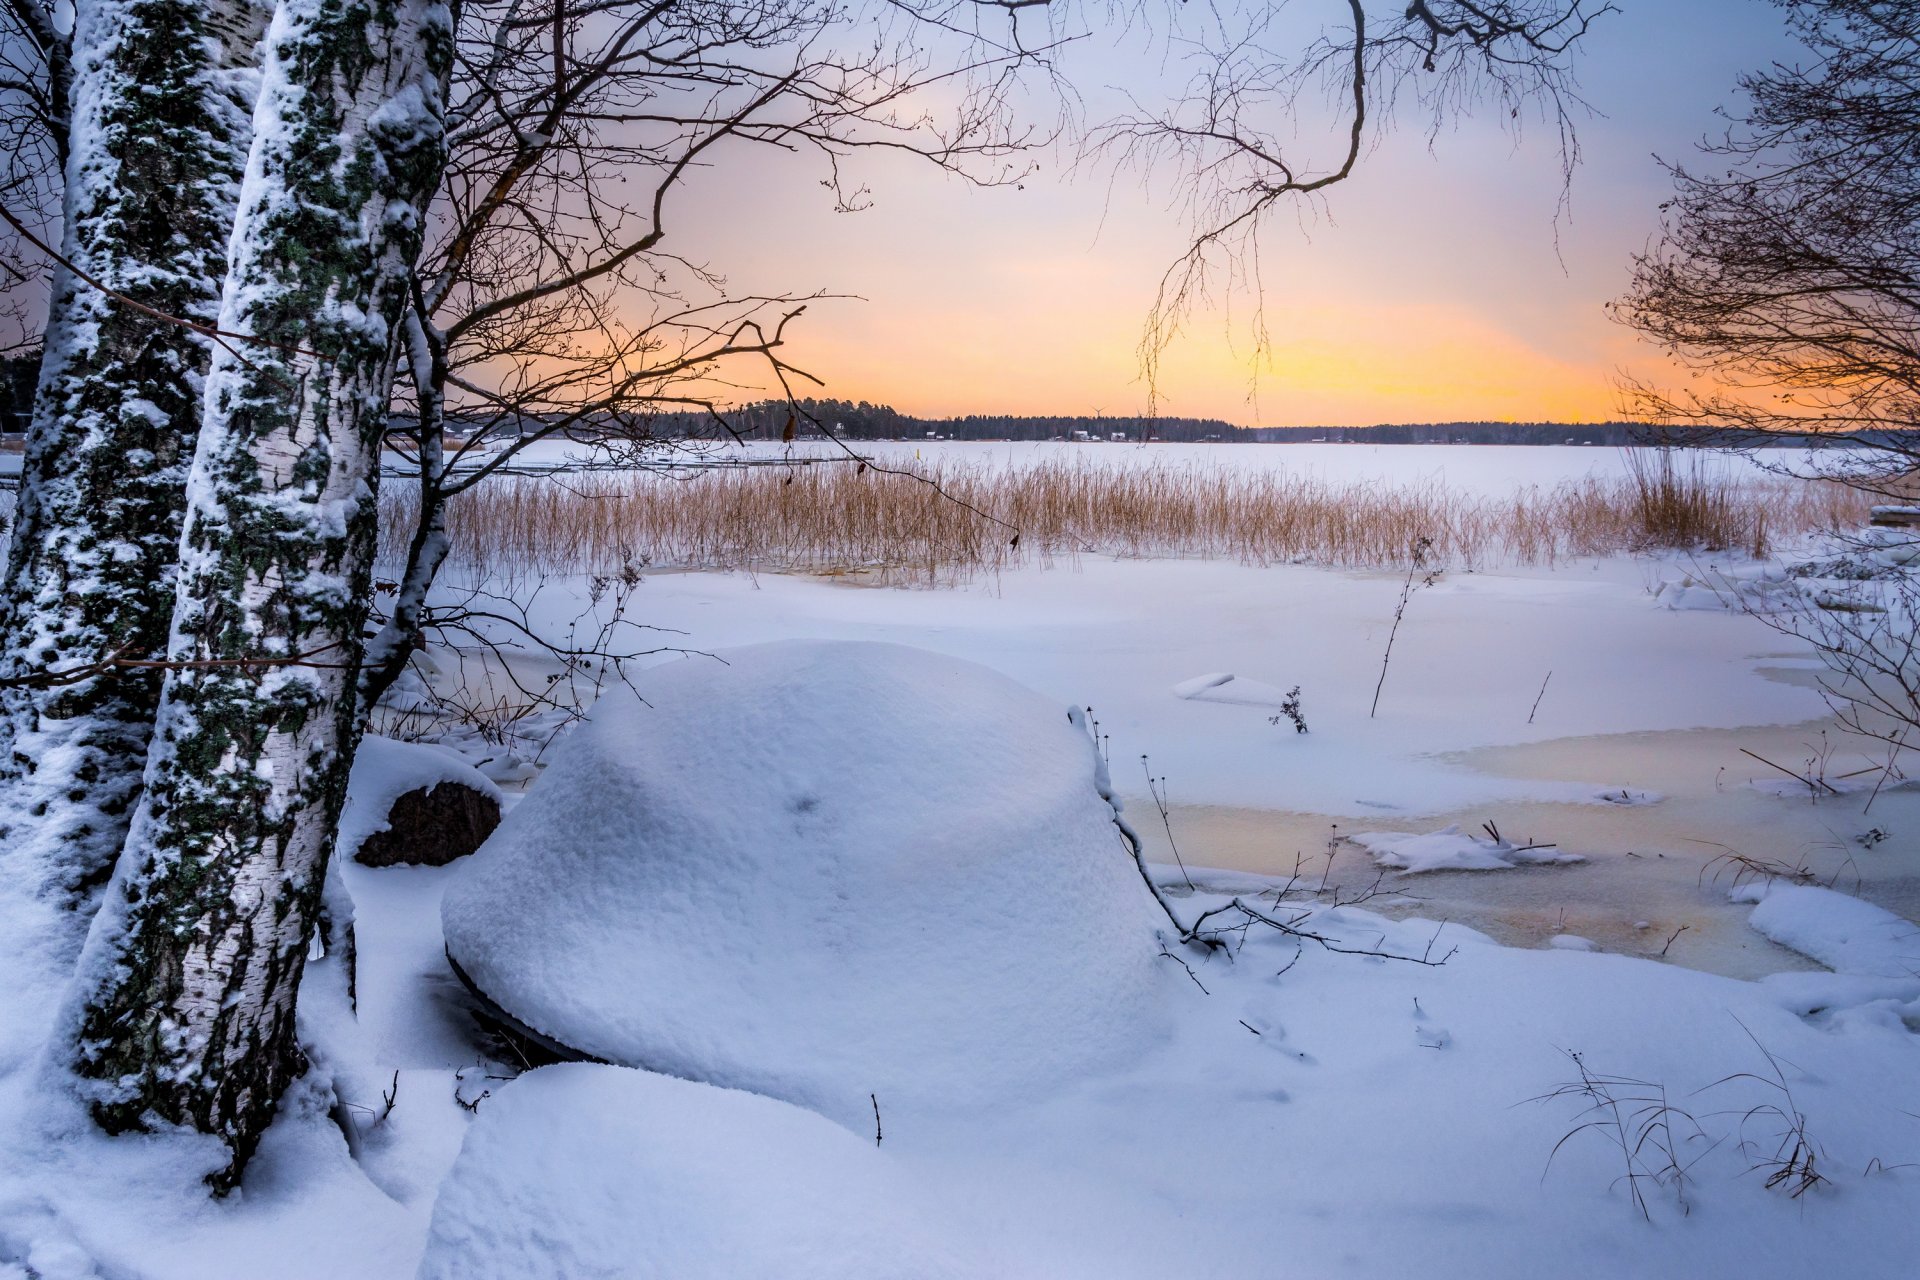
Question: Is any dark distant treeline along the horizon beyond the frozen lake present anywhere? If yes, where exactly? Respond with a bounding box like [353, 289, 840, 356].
[655, 399, 1858, 447]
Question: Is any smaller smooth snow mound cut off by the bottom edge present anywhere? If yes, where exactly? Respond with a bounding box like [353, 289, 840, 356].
[419, 1063, 989, 1280]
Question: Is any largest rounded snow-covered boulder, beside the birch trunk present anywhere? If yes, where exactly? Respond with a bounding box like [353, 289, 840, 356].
[442, 641, 1169, 1128]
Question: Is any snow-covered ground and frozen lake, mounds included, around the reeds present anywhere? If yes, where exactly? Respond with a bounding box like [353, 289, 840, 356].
[0, 441, 1920, 1280]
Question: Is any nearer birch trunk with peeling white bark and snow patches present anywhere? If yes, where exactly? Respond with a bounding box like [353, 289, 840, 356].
[75, 0, 451, 1184]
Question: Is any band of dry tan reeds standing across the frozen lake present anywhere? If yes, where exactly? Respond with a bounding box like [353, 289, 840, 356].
[382, 455, 1870, 585]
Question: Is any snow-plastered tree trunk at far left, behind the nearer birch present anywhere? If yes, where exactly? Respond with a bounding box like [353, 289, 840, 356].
[0, 0, 267, 1059]
